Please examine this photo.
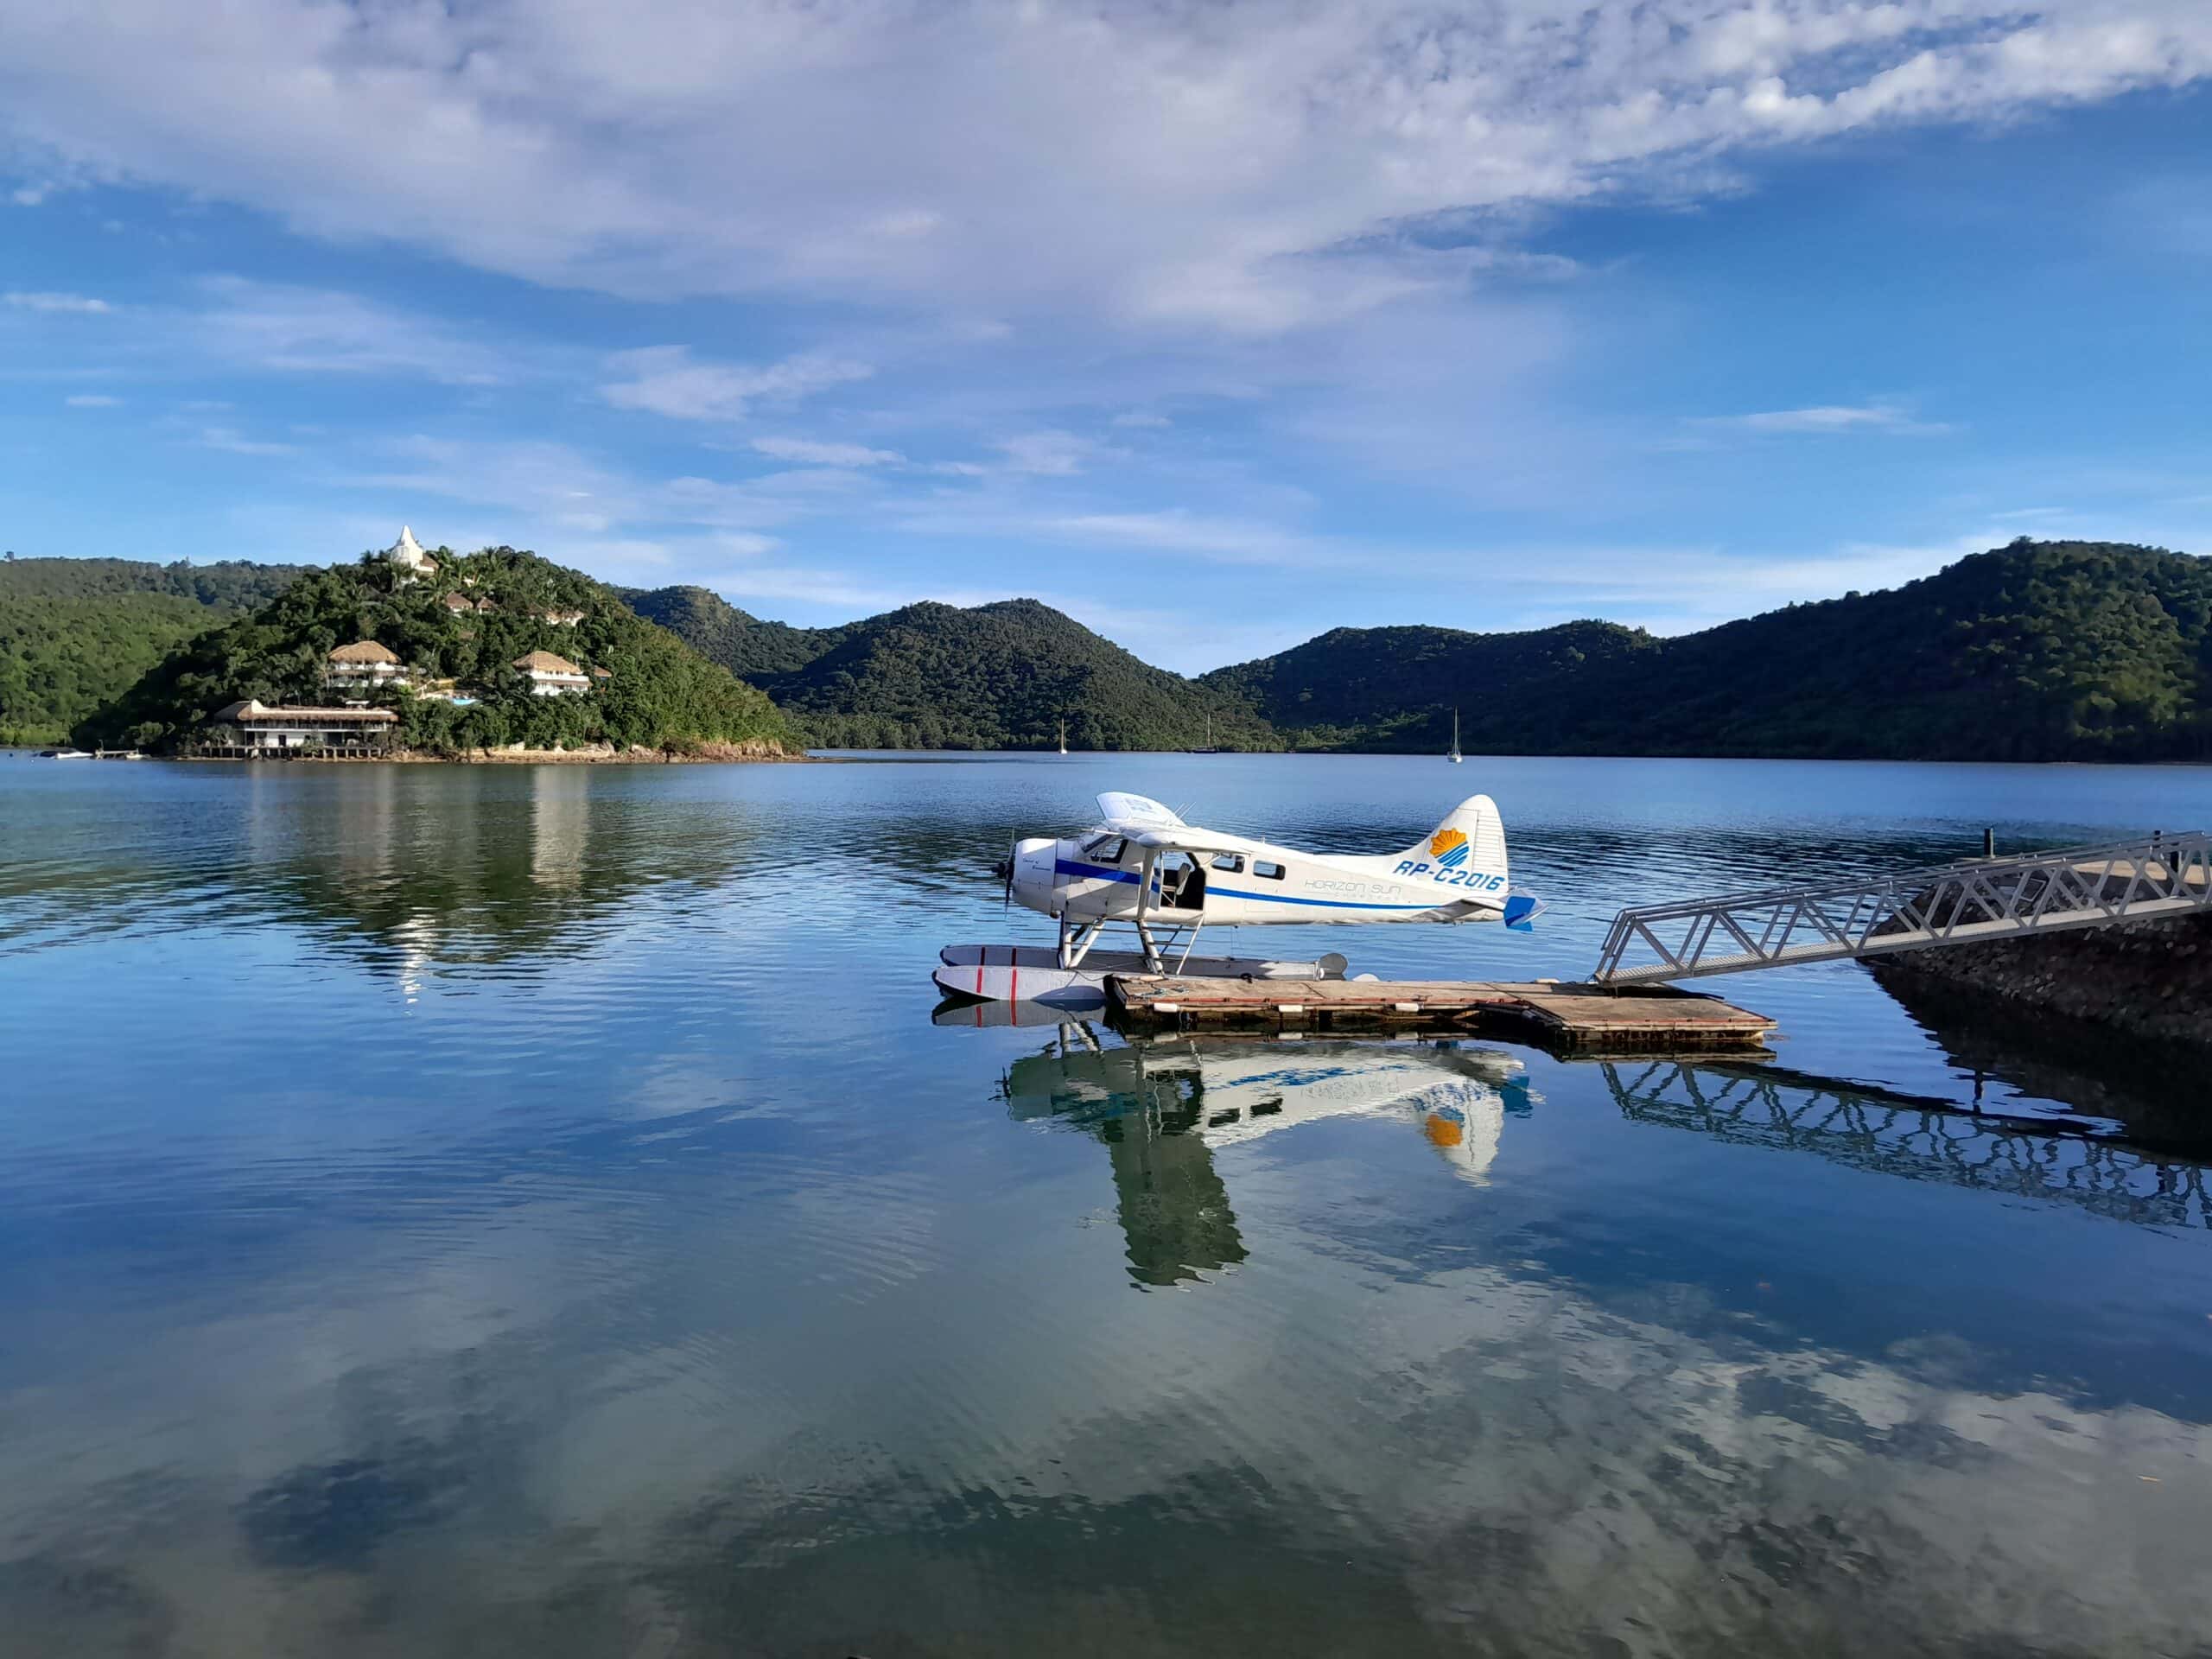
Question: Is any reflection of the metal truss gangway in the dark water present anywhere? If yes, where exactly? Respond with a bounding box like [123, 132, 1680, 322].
[1601, 1062, 2212, 1228]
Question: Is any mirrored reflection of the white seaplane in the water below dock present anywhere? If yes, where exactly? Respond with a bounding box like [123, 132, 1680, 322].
[1002, 1024, 1531, 1285]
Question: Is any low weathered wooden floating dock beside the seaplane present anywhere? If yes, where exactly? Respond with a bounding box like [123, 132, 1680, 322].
[1106, 973, 1774, 1055]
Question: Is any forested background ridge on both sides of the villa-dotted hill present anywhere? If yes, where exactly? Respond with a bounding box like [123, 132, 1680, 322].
[13, 537, 2212, 761]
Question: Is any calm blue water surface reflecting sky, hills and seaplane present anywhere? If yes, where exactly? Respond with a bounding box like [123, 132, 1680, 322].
[0, 757, 2212, 1659]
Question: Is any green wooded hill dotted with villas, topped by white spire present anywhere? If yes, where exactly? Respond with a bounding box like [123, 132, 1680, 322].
[75, 546, 785, 752]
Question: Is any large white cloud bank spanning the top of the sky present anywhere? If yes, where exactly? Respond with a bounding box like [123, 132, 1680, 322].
[0, 0, 2212, 336]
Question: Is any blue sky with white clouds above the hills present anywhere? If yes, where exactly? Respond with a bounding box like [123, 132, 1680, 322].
[0, 0, 2212, 672]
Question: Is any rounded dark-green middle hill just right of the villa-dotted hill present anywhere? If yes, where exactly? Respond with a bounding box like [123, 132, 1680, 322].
[664, 595, 1281, 750]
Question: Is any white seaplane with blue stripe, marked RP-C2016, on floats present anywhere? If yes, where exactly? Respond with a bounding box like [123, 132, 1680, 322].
[933, 791, 1541, 1007]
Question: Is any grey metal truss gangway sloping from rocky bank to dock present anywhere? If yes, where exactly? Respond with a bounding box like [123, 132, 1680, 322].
[1591, 832, 2212, 984]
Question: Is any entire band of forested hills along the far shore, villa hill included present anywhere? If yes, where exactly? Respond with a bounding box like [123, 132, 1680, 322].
[13, 540, 2212, 761]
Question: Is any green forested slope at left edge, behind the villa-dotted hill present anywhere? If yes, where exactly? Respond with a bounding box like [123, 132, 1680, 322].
[0, 560, 305, 743]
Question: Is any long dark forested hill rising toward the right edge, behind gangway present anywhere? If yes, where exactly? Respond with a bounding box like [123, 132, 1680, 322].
[1204, 540, 2212, 761]
